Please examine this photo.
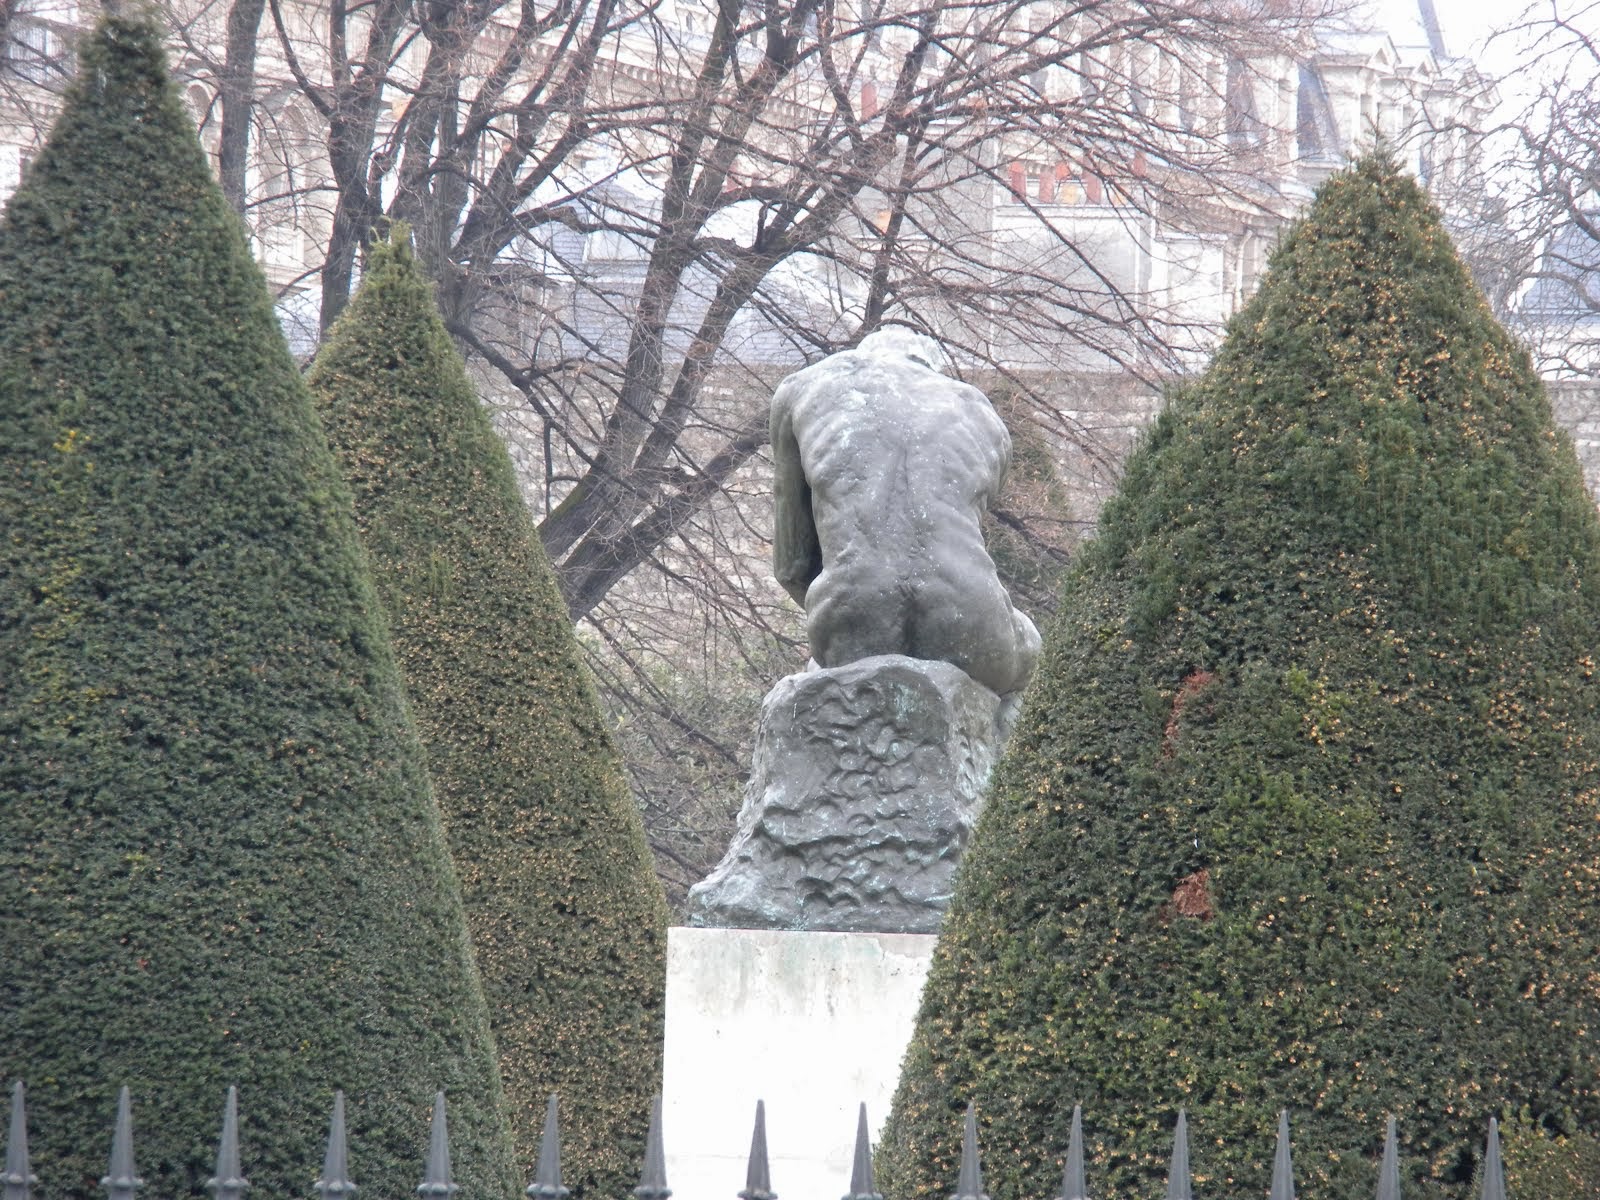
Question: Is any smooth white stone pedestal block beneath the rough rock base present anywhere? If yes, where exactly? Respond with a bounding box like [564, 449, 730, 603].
[662, 926, 936, 1200]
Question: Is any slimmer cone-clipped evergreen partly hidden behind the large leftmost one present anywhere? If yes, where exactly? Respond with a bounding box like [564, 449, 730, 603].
[310, 232, 666, 1197]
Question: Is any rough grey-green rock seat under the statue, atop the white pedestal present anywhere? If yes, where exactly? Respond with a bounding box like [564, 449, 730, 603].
[690, 654, 1010, 933]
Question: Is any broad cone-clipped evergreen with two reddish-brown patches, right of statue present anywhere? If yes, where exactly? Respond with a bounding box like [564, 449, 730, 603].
[882, 158, 1600, 1200]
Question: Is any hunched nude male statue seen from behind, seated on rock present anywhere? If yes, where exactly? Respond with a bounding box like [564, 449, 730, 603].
[771, 328, 1038, 696]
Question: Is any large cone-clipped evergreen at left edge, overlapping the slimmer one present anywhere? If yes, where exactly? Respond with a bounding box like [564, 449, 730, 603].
[0, 16, 517, 1197]
